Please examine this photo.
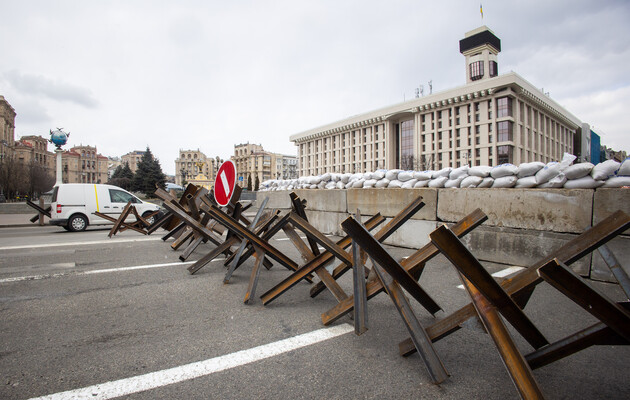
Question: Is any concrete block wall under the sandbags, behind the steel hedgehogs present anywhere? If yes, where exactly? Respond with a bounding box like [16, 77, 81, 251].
[257, 188, 630, 282]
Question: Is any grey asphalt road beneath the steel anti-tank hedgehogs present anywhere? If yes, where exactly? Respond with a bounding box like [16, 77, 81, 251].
[0, 223, 630, 399]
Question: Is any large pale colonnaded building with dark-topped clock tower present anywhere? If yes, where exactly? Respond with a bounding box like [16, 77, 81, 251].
[290, 26, 590, 176]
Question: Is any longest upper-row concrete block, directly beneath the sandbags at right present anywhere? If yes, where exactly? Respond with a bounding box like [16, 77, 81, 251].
[437, 188, 593, 233]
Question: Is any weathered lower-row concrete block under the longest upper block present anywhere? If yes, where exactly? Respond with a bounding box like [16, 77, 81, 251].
[462, 225, 591, 276]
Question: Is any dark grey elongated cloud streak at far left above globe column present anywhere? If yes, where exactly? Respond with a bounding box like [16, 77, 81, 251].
[4, 70, 98, 108]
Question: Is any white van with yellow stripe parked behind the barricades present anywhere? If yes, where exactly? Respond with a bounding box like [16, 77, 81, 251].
[50, 183, 160, 232]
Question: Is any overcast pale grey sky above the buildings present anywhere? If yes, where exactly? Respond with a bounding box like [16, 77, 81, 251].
[0, 0, 630, 174]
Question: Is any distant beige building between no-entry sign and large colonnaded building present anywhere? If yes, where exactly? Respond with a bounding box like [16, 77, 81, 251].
[232, 143, 298, 188]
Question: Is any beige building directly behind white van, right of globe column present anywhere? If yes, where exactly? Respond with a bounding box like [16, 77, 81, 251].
[61, 145, 109, 183]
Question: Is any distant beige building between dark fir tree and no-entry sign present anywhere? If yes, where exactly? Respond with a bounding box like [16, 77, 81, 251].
[175, 149, 222, 188]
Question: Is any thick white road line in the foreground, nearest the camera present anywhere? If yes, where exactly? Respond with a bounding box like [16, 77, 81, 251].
[31, 324, 354, 400]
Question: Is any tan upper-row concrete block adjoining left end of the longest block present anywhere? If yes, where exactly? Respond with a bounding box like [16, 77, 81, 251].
[347, 188, 437, 221]
